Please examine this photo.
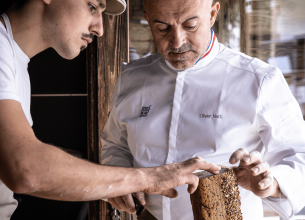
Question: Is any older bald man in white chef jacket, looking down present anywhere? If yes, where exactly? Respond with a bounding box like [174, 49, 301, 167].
[102, 0, 305, 220]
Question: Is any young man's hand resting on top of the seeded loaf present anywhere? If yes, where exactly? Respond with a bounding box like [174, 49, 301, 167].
[144, 157, 221, 198]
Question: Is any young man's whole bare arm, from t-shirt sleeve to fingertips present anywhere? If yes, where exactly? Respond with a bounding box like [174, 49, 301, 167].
[0, 100, 220, 201]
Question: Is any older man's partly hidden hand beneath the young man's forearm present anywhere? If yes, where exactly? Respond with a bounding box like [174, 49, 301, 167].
[108, 192, 146, 214]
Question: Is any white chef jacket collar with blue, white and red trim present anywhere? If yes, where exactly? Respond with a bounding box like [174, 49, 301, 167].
[165, 29, 219, 72]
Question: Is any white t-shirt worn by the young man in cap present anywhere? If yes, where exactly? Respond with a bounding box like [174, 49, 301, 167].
[0, 14, 33, 220]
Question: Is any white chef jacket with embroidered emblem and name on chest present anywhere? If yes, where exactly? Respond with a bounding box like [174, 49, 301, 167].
[101, 33, 305, 220]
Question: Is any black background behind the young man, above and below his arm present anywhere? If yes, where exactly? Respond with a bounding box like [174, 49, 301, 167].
[11, 49, 87, 220]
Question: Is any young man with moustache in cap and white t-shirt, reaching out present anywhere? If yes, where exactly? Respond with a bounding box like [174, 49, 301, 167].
[0, 0, 220, 220]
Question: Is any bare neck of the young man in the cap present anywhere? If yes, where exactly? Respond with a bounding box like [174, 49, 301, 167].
[6, 1, 49, 58]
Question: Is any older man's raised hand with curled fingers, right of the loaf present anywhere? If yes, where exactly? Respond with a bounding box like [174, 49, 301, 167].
[230, 148, 280, 198]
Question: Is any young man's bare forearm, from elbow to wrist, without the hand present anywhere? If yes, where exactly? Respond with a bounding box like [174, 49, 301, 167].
[3, 143, 145, 201]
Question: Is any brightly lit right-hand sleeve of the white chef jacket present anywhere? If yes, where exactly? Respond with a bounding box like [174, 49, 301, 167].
[257, 68, 305, 219]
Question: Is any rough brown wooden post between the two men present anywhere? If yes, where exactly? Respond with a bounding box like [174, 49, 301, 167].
[97, 12, 129, 148]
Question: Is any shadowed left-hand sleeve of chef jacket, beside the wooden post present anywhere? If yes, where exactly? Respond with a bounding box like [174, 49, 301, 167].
[101, 70, 133, 167]
